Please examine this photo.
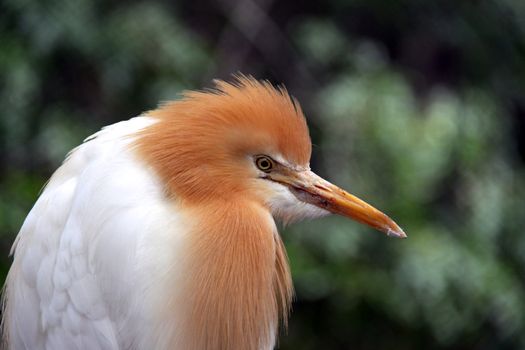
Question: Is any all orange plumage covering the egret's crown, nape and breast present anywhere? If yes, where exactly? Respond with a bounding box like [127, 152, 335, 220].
[131, 78, 304, 350]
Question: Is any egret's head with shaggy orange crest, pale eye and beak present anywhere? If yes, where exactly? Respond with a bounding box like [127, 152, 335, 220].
[139, 76, 406, 237]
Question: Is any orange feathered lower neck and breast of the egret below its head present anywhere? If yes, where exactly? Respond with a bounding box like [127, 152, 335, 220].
[174, 203, 292, 350]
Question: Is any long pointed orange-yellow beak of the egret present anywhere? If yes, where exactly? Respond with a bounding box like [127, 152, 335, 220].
[271, 171, 407, 238]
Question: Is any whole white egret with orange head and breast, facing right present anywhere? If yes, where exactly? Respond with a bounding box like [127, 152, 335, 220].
[3, 74, 406, 350]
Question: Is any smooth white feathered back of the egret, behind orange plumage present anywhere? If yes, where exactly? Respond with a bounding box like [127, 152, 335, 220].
[3, 117, 188, 350]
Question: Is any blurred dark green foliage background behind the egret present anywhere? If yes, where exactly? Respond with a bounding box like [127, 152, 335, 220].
[0, 0, 525, 350]
